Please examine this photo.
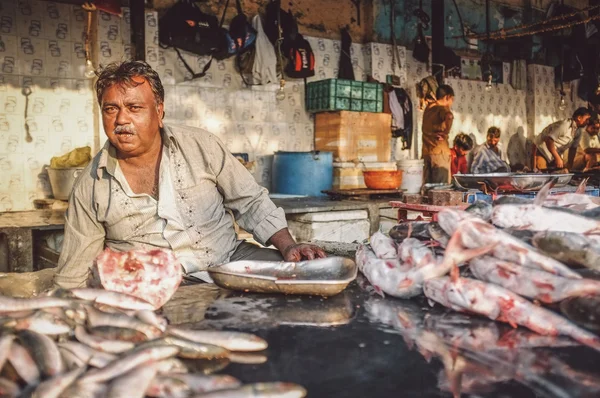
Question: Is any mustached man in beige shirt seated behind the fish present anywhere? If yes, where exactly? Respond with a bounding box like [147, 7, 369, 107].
[54, 61, 325, 288]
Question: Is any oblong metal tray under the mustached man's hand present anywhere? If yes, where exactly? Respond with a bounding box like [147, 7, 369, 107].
[208, 257, 358, 296]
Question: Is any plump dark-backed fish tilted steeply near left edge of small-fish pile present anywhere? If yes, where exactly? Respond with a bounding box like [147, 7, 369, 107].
[17, 330, 65, 378]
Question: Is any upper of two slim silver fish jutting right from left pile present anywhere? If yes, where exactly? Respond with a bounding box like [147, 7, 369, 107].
[167, 326, 268, 351]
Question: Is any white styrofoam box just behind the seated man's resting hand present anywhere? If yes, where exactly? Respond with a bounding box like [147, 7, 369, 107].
[288, 219, 370, 243]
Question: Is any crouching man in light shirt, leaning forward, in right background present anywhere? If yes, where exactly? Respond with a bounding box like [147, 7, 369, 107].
[533, 108, 591, 170]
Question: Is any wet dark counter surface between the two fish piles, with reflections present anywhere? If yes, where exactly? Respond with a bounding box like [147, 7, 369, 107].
[164, 282, 600, 398]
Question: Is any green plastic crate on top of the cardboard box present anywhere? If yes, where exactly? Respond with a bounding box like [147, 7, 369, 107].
[306, 79, 383, 113]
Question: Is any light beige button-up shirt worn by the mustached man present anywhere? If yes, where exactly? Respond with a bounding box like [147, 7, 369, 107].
[55, 126, 287, 288]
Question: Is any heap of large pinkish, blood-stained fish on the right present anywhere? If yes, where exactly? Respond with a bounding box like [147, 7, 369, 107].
[356, 180, 600, 350]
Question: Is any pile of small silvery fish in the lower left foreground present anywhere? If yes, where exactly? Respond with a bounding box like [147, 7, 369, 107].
[0, 288, 306, 398]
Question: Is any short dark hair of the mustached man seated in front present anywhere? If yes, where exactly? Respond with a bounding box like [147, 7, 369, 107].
[96, 61, 165, 105]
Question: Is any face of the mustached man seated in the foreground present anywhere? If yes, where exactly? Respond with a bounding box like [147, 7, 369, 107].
[101, 77, 164, 157]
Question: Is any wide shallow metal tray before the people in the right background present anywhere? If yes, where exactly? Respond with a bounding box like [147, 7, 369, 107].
[454, 173, 573, 192]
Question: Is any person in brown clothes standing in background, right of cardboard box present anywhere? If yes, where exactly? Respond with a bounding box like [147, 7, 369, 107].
[422, 84, 454, 184]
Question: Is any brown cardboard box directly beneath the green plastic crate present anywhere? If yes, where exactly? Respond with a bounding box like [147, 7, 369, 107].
[315, 111, 392, 162]
